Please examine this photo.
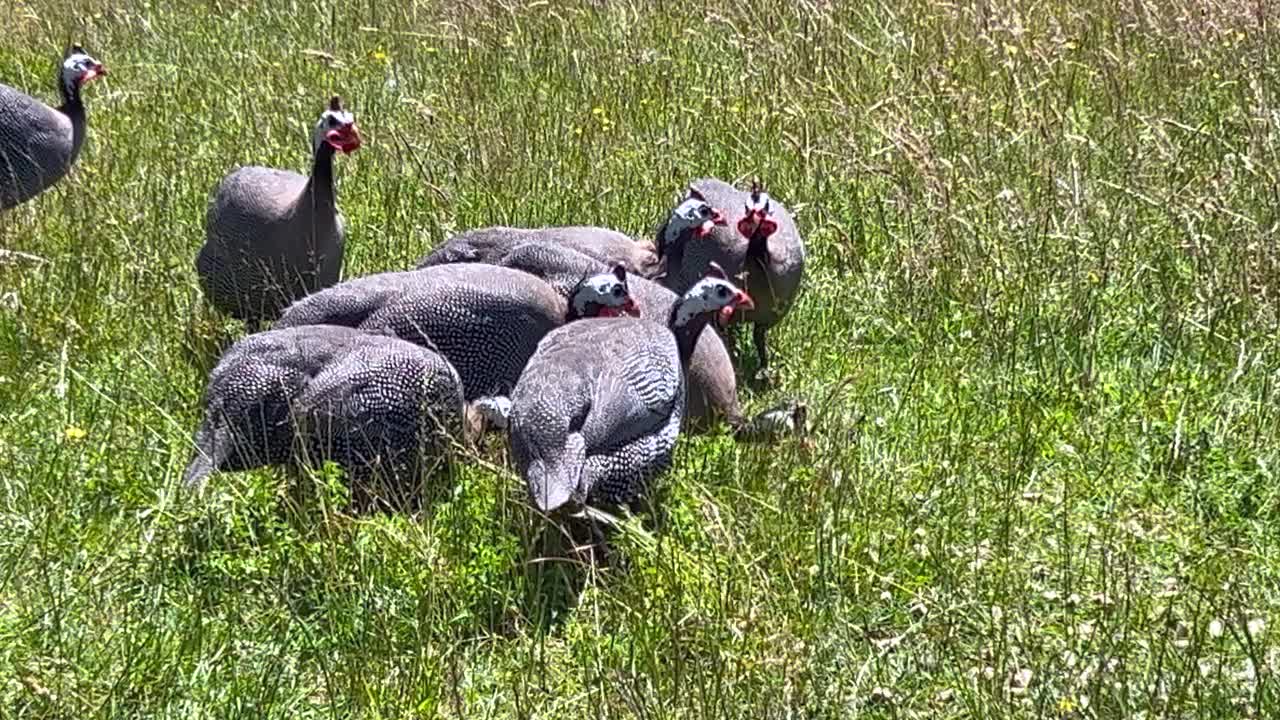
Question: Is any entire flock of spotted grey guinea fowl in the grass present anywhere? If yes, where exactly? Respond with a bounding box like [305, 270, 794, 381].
[0, 46, 805, 514]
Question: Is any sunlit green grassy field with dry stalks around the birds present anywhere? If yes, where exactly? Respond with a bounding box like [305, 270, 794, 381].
[0, 0, 1280, 719]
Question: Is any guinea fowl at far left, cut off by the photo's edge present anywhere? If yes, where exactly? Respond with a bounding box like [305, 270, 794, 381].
[0, 45, 106, 210]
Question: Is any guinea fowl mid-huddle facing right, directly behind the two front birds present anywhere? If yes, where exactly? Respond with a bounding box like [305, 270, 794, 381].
[275, 263, 635, 402]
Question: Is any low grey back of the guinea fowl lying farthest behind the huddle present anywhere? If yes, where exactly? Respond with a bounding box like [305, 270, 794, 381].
[417, 225, 658, 277]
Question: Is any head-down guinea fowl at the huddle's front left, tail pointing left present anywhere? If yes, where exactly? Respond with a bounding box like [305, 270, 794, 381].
[183, 325, 462, 497]
